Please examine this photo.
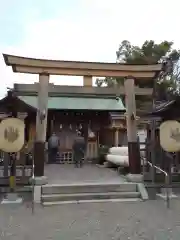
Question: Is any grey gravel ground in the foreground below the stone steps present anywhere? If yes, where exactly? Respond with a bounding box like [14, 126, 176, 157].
[0, 199, 180, 240]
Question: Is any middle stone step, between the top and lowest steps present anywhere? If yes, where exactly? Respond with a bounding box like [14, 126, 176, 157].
[41, 192, 140, 202]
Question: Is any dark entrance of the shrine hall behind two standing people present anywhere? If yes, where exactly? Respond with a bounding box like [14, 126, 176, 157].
[47, 110, 110, 164]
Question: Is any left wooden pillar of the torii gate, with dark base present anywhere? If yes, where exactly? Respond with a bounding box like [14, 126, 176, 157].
[34, 73, 49, 177]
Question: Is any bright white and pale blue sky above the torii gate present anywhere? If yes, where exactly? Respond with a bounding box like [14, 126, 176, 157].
[0, 0, 180, 98]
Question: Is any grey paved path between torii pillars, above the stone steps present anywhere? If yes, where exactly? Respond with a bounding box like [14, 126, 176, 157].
[45, 164, 124, 184]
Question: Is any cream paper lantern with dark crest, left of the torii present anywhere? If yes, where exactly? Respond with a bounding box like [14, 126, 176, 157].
[0, 118, 25, 153]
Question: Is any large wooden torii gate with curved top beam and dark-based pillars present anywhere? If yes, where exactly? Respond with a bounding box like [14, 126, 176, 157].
[3, 54, 163, 182]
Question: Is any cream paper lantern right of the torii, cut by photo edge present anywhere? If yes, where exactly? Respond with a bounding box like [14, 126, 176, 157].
[160, 120, 180, 152]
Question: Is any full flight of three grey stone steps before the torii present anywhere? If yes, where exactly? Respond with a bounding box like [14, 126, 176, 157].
[41, 183, 141, 206]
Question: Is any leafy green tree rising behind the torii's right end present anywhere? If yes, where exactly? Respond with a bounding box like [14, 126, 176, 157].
[96, 40, 180, 100]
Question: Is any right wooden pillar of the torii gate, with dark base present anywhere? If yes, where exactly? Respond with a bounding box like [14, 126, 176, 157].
[124, 77, 141, 174]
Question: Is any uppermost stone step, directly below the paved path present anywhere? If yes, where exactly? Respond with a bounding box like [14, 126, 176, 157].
[42, 183, 137, 195]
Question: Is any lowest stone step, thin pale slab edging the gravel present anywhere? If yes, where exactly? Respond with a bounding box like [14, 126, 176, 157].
[42, 198, 142, 207]
